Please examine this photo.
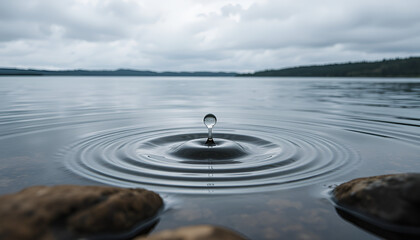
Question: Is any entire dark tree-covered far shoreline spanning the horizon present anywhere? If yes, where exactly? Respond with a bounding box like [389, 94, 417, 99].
[0, 57, 420, 77]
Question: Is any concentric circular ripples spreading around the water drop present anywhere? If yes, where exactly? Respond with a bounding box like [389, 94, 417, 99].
[64, 125, 359, 193]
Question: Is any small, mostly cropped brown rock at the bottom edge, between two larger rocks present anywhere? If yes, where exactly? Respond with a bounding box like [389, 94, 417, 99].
[134, 225, 246, 240]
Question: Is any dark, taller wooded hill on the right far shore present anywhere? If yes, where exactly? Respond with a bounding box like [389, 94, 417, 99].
[238, 57, 420, 77]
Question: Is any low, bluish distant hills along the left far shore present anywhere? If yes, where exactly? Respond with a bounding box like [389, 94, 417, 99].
[0, 68, 237, 77]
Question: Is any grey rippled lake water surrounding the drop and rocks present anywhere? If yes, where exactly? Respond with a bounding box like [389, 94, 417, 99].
[0, 77, 420, 239]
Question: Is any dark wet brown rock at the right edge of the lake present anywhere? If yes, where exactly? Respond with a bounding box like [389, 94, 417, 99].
[333, 173, 420, 227]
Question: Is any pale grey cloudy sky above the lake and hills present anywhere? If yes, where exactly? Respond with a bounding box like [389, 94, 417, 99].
[0, 0, 420, 72]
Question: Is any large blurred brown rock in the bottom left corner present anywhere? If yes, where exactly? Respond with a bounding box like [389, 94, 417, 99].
[0, 185, 163, 240]
